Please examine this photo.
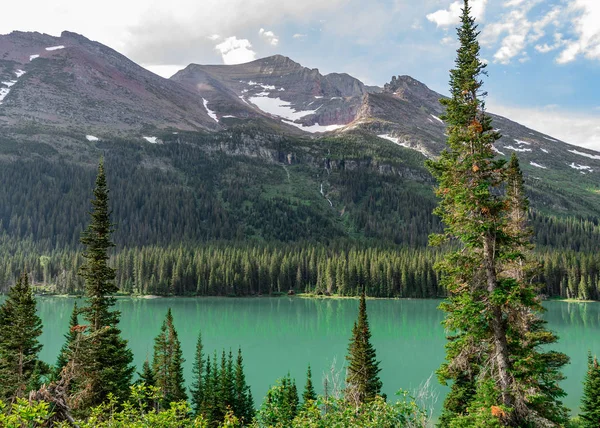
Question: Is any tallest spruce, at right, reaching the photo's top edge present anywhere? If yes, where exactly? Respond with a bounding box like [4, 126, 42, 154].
[427, 0, 564, 427]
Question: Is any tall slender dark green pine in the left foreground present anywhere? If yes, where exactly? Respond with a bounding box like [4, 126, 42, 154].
[72, 160, 135, 407]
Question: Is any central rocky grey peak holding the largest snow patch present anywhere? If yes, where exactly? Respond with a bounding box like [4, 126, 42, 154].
[171, 55, 366, 133]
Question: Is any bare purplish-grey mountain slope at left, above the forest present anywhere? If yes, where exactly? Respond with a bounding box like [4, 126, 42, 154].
[0, 31, 220, 134]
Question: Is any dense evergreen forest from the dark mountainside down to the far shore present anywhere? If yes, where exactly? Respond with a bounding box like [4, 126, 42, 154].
[0, 139, 600, 299]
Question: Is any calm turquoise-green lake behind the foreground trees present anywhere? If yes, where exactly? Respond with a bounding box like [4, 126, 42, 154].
[38, 297, 600, 413]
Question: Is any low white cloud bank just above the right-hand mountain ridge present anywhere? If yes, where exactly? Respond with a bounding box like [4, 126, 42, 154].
[487, 98, 600, 151]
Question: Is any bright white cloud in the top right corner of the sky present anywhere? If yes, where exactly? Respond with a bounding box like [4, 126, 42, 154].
[556, 0, 600, 64]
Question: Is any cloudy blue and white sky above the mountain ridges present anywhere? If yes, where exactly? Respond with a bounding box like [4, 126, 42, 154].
[0, 0, 600, 150]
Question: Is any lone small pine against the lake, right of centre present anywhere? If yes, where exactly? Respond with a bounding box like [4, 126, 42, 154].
[346, 292, 382, 403]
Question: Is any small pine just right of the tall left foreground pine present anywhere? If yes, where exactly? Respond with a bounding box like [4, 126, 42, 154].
[152, 308, 187, 408]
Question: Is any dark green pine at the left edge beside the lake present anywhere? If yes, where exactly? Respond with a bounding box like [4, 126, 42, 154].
[0, 272, 42, 401]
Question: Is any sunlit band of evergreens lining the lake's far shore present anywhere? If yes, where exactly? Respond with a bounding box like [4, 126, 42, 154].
[0, 238, 600, 300]
